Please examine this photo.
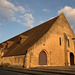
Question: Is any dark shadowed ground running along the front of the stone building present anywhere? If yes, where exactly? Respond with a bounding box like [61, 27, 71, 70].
[0, 66, 75, 75]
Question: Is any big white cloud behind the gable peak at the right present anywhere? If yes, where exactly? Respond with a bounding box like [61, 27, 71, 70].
[58, 6, 75, 27]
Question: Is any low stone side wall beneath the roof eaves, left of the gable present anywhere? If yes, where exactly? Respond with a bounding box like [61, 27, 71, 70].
[1, 55, 25, 68]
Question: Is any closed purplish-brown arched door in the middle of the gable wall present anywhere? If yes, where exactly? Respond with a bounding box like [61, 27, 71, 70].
[39, 51, 47, 65]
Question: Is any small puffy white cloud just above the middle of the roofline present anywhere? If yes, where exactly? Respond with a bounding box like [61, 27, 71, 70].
[20, 13, 34, 27]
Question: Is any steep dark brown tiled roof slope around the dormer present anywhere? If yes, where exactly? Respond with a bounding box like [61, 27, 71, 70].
[4, 17, 58, 57]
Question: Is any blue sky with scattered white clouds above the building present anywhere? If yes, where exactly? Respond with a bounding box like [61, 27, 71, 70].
[0, 0, 75, 43]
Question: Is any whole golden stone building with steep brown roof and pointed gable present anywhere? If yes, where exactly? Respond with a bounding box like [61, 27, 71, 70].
[0, 13, 75, 68]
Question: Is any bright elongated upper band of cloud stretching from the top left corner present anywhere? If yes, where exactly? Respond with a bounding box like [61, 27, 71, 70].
[0, 0, 25, 12]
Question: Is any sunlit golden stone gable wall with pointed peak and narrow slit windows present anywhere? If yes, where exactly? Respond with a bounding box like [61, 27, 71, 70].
[26, 14, 75, 68]
